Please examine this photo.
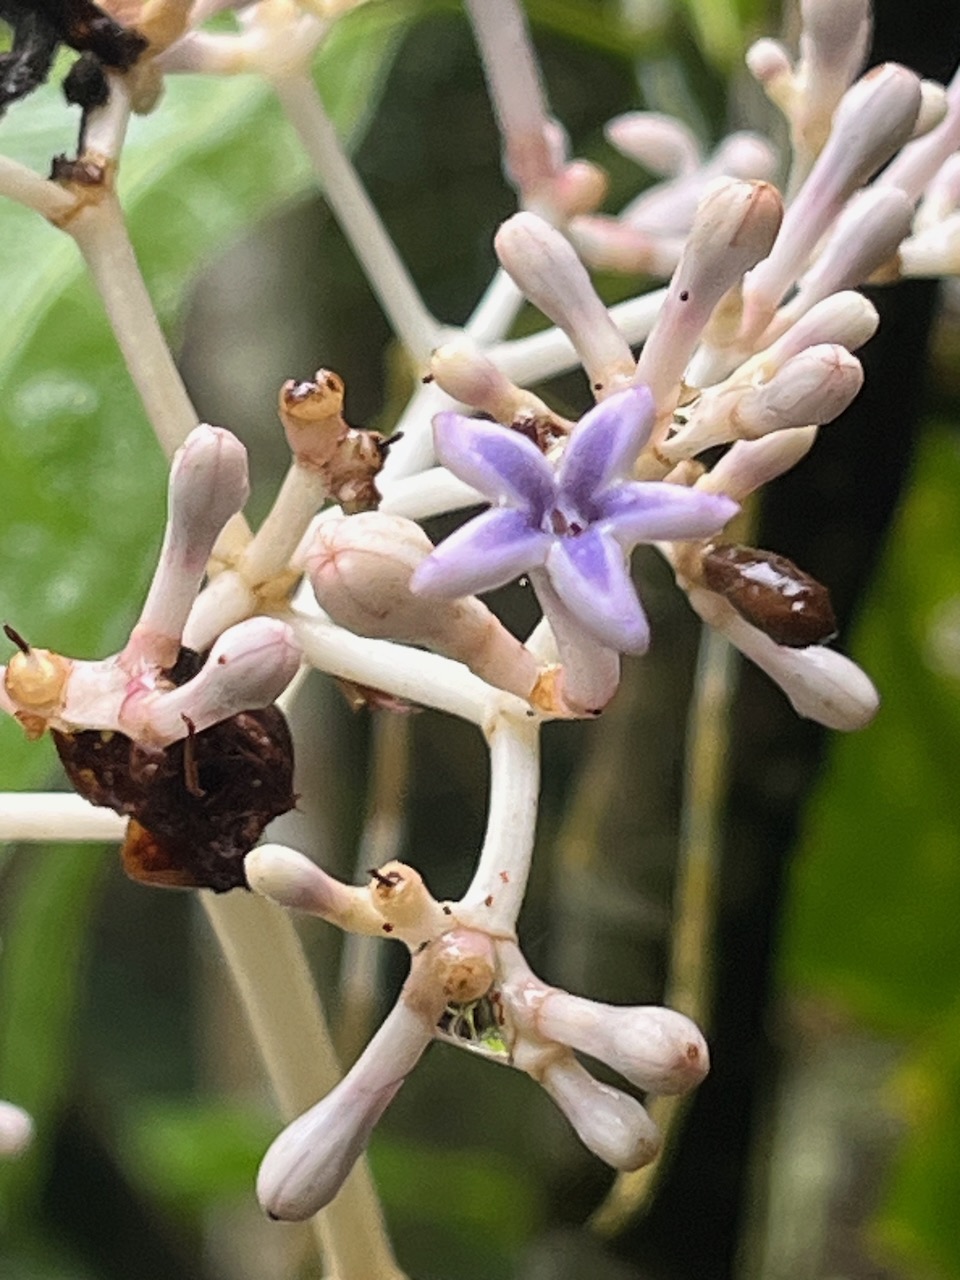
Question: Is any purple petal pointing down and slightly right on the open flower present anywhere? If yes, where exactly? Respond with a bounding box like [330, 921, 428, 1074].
[547, 529, 650, 653]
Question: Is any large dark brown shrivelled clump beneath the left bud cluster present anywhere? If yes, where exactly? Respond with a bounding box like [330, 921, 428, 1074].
[52, 649, 297, 893]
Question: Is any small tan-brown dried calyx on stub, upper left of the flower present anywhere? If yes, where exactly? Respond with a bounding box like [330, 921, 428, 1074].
[279, 369, 398, 516]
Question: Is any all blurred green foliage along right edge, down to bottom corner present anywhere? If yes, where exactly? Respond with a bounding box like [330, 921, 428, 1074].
[783, 425, 960, 1277]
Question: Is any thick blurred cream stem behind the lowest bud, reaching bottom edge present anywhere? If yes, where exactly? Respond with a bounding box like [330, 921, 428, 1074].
[200, 892, 403, 1280]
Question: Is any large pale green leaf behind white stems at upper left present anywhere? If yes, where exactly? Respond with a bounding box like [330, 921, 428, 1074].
[0, 5, 408, 788]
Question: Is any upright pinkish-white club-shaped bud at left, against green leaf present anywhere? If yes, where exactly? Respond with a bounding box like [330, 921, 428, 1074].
[120, 425, 250, 669]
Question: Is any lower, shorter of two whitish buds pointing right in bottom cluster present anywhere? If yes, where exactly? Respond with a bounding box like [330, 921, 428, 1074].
[539, 1053, 660, 1170]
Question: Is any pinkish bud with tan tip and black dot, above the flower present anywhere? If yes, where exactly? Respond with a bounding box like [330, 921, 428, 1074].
[634, 179, 783, 415]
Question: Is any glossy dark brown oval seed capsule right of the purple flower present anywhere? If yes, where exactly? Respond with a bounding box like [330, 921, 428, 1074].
[703, 543, 837, 649]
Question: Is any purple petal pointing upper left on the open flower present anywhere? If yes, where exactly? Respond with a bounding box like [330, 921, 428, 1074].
[434, 413, 554, 521]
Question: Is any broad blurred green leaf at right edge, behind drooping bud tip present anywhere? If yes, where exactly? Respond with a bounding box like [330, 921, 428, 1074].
[783, 431, 960, 1034]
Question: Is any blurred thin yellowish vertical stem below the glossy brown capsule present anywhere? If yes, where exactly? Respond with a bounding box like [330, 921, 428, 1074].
[590, 627, 736, 1235]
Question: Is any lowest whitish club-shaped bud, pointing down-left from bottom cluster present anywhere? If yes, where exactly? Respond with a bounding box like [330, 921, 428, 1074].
[257, 998, 443, 1222]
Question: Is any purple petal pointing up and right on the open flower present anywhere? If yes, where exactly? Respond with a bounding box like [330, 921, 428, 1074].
[557, 387, 654, 506]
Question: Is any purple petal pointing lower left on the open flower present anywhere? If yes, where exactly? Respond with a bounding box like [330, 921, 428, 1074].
[410, 509, 553, 599]
